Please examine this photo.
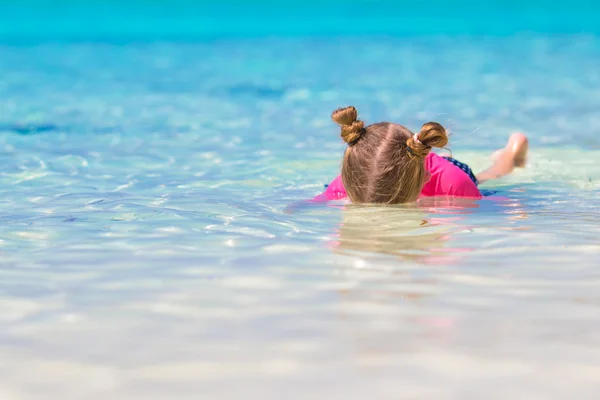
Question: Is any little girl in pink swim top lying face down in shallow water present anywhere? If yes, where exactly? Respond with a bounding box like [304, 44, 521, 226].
[314, 107, 528, 204]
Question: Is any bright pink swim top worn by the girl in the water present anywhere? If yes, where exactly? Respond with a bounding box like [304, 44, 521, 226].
[313, 153, 483, 201]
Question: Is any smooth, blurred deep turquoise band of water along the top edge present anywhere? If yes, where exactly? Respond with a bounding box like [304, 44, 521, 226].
[0, 0, 600, 41]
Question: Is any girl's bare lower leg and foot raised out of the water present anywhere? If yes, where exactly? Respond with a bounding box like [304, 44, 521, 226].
[477, 133, 529, 183]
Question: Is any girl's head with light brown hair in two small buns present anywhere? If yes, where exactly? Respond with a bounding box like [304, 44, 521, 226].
[331, 106, 448, 204]
